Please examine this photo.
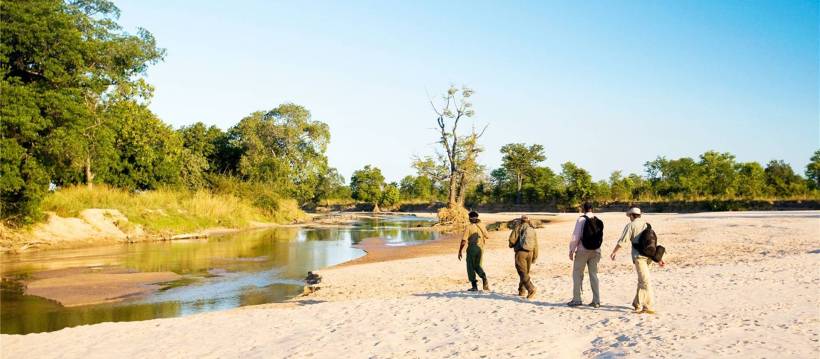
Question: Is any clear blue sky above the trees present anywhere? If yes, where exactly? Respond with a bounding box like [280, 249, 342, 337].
[115, 0, 820, 180]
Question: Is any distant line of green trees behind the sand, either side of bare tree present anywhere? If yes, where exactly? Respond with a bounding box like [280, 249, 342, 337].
[344, 148, 820, 210]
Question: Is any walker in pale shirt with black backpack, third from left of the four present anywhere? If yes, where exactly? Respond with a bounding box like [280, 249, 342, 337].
[567, 202, 604, 308]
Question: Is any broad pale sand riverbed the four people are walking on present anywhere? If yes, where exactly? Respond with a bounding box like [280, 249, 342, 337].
[0, 212, 820, 358]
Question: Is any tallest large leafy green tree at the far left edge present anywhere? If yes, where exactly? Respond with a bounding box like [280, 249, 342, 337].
[0, 0, 163, 222]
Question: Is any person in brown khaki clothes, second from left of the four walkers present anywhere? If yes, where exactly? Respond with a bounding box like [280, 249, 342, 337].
[509, 215, 538, 299]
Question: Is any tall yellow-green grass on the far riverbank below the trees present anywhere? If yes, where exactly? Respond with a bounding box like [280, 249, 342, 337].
[42, 185, 304, 233]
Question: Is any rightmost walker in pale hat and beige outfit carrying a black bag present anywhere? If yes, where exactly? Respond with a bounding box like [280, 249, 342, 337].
[609, 207, 665, 314]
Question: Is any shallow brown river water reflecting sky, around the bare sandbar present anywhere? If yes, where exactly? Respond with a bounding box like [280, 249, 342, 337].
[0, 217, 438, 334]
